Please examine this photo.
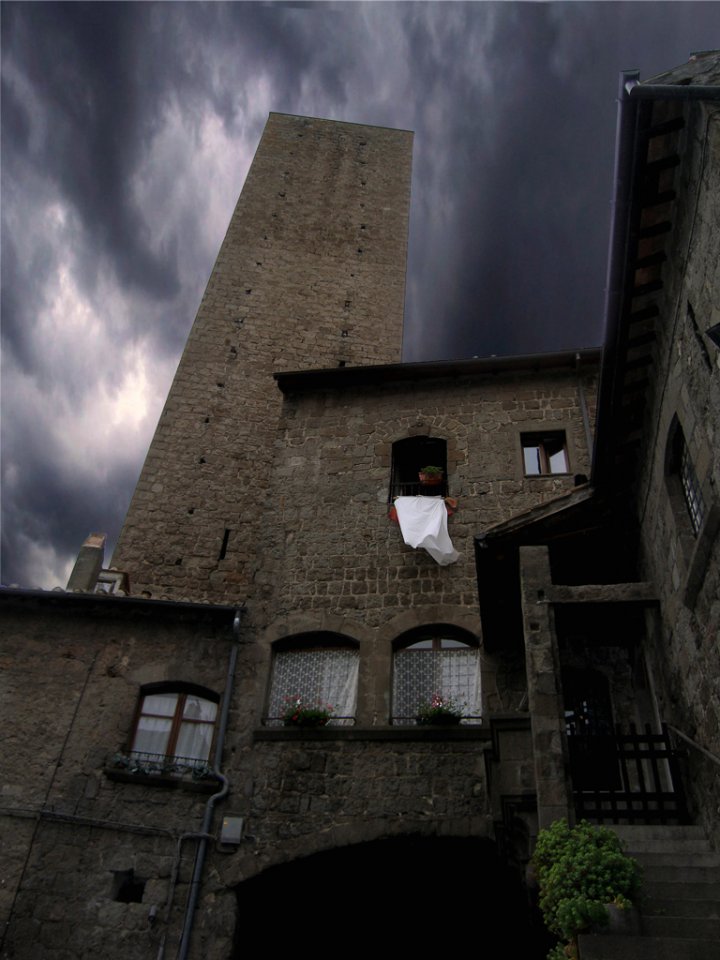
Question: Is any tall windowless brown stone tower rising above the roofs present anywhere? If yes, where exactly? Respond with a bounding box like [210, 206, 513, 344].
[113, 113, 412, 602]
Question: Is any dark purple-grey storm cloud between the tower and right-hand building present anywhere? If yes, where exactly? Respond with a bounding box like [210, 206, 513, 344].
[406, 4, 720, 359]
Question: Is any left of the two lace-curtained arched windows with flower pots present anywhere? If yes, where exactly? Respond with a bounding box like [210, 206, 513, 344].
[267, 632, 360, 726]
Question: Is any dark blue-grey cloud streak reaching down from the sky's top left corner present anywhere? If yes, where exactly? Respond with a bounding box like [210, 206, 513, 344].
[3, 3, 177, 297]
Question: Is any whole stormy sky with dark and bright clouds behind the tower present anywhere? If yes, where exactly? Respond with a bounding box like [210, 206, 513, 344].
[0, 2, 720, 588]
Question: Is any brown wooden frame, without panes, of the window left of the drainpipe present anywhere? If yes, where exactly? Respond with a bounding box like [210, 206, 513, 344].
[127, 682, 220, 767]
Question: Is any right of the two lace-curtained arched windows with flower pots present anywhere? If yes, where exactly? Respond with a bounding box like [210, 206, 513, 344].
[392, 626, 481, 724]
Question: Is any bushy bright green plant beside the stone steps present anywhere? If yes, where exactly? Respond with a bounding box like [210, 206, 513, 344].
[533, 820, 641, 960]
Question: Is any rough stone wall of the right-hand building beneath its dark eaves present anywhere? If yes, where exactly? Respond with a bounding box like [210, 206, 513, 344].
[637, 97, 720, 829]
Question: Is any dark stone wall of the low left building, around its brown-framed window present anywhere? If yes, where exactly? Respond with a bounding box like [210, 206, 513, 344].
[0, 593, 234, 960]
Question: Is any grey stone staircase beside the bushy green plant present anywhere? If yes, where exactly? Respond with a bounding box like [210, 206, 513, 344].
[578, 826, 720, 960]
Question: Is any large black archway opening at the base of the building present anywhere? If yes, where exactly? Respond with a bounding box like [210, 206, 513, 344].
[233, 836, 548, 960]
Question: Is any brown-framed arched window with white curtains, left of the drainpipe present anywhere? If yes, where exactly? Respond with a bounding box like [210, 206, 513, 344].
[130, 683, 220, 766]
